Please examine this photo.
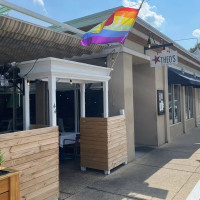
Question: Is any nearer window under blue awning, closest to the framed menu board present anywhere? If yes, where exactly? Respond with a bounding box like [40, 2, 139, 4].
[169, 85, 181, 124]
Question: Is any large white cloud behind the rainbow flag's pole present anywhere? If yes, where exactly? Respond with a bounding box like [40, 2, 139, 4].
[123, 0, 165, 27]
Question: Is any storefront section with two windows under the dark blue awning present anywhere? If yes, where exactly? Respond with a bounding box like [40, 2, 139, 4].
[168, 67, 200, 137]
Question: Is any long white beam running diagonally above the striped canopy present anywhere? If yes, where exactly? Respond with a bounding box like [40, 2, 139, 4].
[0, 0, 85, 35]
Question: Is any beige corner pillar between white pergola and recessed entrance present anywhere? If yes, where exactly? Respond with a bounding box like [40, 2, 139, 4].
[108, 53, 135, 162]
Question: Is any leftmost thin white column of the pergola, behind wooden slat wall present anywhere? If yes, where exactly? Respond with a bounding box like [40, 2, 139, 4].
[23, 78, 30, 130]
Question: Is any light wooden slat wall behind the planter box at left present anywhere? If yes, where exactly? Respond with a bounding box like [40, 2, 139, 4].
[0, 127, 59, 200]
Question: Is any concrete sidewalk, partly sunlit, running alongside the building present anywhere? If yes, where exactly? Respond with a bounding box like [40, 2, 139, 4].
[61, 128, 200, 200]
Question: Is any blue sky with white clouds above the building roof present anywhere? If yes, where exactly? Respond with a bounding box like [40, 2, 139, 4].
[3, 0, 200, 49]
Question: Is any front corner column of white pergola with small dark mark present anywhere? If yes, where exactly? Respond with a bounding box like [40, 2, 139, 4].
[48, 76, 57, 126]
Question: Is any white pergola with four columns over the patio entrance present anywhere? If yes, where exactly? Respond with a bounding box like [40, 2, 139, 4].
[19, 57, 112, 130]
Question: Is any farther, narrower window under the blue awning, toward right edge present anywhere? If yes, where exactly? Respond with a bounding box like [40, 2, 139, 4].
[185, 87, 194, 119]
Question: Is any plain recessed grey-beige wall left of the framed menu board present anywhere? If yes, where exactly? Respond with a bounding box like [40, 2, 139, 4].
[133, 64, 158, 145]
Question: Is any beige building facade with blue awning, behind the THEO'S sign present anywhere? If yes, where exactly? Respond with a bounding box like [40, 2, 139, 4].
[67, 9, 200, 161]
